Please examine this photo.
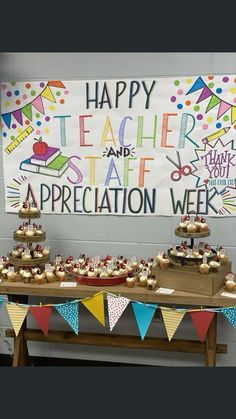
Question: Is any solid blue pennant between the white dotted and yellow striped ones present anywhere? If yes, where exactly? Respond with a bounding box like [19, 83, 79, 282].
[132, 302, 157, 339]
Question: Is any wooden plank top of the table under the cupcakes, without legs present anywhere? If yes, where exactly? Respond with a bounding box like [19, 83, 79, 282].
[0, 279, 236, 307]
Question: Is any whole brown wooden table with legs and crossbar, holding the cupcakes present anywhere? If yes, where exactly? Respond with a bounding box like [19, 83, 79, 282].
[0, 281, 234, 367]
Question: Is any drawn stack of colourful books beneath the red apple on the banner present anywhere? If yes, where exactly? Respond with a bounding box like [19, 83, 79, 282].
[20, 147, 68, 177]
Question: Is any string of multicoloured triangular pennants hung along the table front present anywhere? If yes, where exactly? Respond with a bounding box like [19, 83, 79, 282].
[0, 291, 236, 342]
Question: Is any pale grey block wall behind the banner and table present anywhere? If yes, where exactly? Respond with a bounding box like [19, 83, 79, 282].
[0, 53, 236, 366]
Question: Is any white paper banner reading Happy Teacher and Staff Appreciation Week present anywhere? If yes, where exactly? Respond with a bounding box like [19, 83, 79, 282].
[0, 74, 236, 217]
